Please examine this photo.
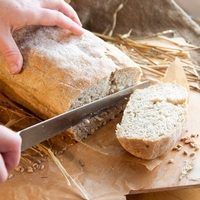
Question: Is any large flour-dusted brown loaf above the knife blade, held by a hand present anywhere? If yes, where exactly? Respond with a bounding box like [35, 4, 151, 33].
[0, 27, 141, 139]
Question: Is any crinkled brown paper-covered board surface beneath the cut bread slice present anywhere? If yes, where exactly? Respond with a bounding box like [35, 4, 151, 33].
[0, 93, 200, 200]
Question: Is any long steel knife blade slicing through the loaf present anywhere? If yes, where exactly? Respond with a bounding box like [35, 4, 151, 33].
[18, 81, 151, 151]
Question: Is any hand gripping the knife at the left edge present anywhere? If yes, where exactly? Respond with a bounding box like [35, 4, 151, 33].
[0, 125, 21, 182]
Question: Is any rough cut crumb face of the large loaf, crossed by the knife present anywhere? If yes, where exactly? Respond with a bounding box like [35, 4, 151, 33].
[70, 67, 142, 139]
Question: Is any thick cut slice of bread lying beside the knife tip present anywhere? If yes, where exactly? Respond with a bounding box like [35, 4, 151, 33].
[116, 83, 188, 159]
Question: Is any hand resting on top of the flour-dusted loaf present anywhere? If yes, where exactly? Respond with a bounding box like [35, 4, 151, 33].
[0, 0, 83, 74]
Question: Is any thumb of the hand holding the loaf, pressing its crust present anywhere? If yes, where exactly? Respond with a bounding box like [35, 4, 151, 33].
[0, 31, 23, 74]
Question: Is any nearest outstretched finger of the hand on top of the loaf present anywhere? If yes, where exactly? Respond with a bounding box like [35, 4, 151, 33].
[32, 9, 84, 35]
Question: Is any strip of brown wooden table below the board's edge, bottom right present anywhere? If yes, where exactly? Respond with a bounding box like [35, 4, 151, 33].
[127, 188, 200, 200]
